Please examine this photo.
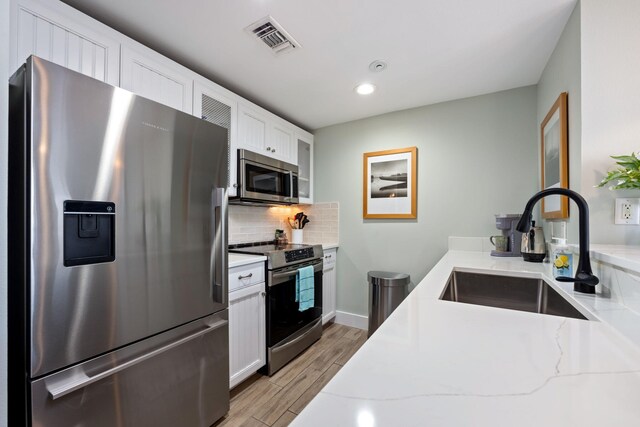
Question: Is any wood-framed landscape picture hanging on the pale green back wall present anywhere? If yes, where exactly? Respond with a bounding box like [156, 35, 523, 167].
[362, 147, 418, 219]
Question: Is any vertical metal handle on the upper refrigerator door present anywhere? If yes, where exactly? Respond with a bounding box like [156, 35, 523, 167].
[210, 188, 227, 305]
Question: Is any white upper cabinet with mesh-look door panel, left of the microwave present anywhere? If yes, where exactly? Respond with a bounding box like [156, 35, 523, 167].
[193, 79, 238, 197]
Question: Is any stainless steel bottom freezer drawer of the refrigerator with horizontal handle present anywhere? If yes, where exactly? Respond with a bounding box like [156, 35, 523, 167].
[31, 310, 229, 427]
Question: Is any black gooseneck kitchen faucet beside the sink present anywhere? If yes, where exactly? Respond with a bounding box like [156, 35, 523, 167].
[516, 188, 600, 294]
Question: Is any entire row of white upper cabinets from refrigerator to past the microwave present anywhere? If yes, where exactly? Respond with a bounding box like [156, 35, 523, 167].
[9, 0, 313, 192]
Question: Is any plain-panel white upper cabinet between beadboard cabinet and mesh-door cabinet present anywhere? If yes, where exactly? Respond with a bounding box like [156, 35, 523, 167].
[120, 45, 193, 114]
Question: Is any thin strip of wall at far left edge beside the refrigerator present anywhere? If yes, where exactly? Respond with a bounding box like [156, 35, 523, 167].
[0, 0, 9, 426]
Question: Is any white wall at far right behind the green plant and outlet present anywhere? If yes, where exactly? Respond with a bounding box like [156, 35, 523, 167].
[580, 0, 640, 245]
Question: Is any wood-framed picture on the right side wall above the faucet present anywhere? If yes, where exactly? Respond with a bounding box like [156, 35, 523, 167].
[540, 92, 569, 219]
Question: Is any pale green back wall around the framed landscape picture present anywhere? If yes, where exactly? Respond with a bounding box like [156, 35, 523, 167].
[314, 86, 538, 315]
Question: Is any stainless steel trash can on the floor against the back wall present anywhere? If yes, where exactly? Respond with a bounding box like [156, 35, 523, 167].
[367, 271, 411, 338]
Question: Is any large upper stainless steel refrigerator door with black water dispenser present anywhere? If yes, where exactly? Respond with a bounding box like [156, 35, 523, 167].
[23, 57, 227, 378]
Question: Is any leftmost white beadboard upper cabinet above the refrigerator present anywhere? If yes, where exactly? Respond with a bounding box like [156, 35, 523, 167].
[10, 0, 120, 86]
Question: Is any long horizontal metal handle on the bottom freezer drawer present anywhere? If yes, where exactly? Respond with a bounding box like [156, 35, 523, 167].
[47, 320, 229, 400]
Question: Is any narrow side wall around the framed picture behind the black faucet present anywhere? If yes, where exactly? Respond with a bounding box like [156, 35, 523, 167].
[538, 3, 582, 243]
